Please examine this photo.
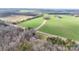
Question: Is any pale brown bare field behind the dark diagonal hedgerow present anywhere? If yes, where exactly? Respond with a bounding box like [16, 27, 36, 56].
[0, 15, 34, 23]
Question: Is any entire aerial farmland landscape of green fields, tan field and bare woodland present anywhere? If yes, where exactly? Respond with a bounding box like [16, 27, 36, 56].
[0, 8, 79, 51]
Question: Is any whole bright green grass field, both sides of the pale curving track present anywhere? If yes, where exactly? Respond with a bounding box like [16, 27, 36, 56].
[18, 15, 79, 40]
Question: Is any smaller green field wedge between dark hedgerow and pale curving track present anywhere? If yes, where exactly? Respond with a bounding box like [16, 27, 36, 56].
[18, 17, 44, 28]
